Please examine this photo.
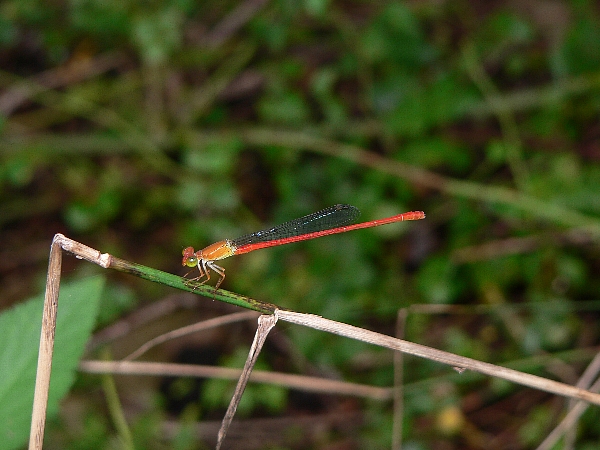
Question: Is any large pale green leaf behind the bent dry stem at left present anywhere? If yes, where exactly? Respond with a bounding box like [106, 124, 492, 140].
[0, 277, 104, 449]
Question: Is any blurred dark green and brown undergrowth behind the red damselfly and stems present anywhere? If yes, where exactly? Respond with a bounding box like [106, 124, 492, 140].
[0, 0, 600, 449]
